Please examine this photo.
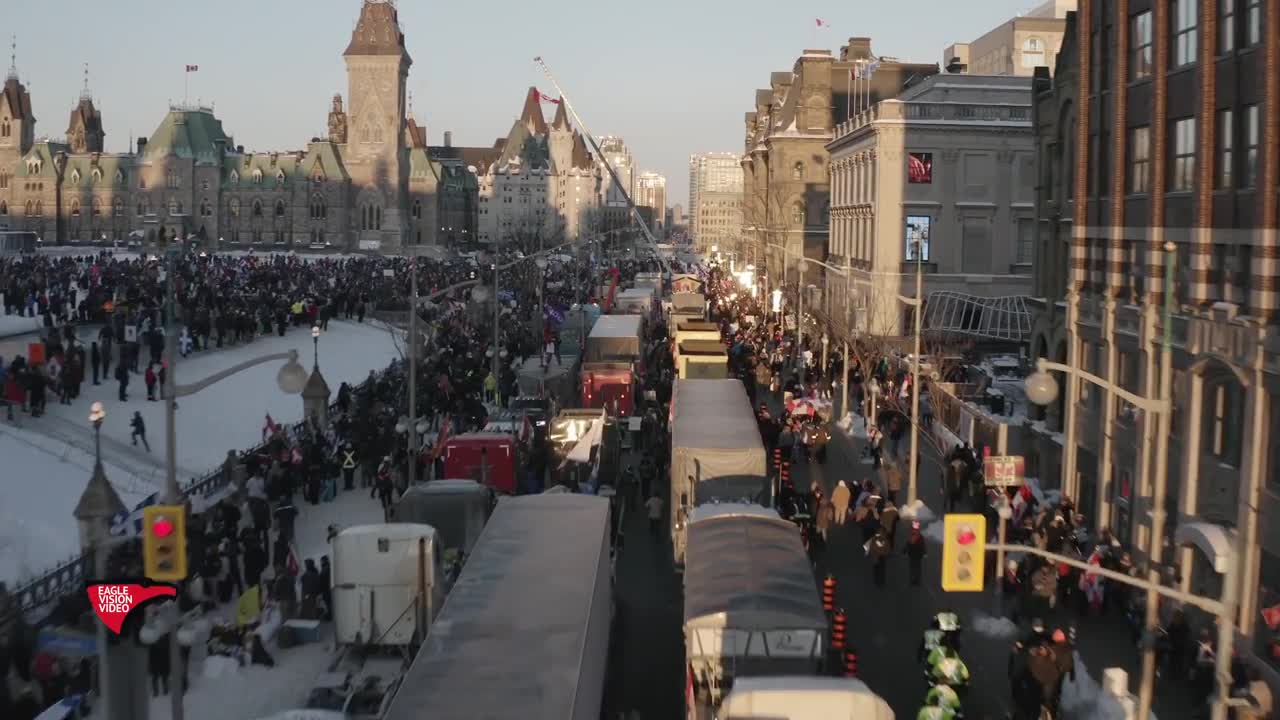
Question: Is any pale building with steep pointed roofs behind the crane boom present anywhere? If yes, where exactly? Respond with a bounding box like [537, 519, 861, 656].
[472, 87, 607, 250]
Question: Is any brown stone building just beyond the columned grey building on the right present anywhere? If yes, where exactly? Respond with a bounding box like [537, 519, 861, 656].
[742, 37, 938, 284]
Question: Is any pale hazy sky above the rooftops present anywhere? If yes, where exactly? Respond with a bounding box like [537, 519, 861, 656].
[0, 0, 1033, 205]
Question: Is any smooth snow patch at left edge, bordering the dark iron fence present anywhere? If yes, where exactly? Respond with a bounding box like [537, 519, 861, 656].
[0, 424, 155, 587]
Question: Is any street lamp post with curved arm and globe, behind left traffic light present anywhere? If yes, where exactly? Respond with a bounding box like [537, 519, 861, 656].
[164, 243, 307, 720]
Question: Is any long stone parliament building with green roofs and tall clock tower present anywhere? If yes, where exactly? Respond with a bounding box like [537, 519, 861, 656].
[0, 0, 477, 251]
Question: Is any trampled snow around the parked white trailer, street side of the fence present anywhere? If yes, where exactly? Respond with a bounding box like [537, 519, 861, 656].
[93, 486, 383, 720]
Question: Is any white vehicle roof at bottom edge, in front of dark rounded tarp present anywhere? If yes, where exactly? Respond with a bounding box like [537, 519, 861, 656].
[719, 675, 893, 720]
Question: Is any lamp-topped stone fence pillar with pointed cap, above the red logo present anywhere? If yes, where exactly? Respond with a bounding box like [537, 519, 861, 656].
[74, 402, 127, 717]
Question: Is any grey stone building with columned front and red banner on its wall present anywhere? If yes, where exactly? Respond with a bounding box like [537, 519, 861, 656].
[823, 74, 1037, 337]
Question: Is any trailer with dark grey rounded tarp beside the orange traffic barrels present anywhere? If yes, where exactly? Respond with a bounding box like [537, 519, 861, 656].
[684, 503, 827, 720]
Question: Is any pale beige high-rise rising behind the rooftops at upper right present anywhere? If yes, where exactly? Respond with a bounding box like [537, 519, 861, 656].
[942, 0, 1076, 77]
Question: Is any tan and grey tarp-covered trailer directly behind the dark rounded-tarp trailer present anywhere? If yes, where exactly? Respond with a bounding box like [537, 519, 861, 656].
[669, 379, 769, 568]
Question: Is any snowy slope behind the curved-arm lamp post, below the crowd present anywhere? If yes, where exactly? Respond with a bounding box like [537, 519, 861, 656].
[45, 320, 399, 473]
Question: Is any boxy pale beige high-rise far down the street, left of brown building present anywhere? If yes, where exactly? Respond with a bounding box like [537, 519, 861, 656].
[689, 152, 742, 251]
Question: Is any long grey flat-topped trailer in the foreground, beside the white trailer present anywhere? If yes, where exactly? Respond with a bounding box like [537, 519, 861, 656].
[383, 493, 613, 720]
